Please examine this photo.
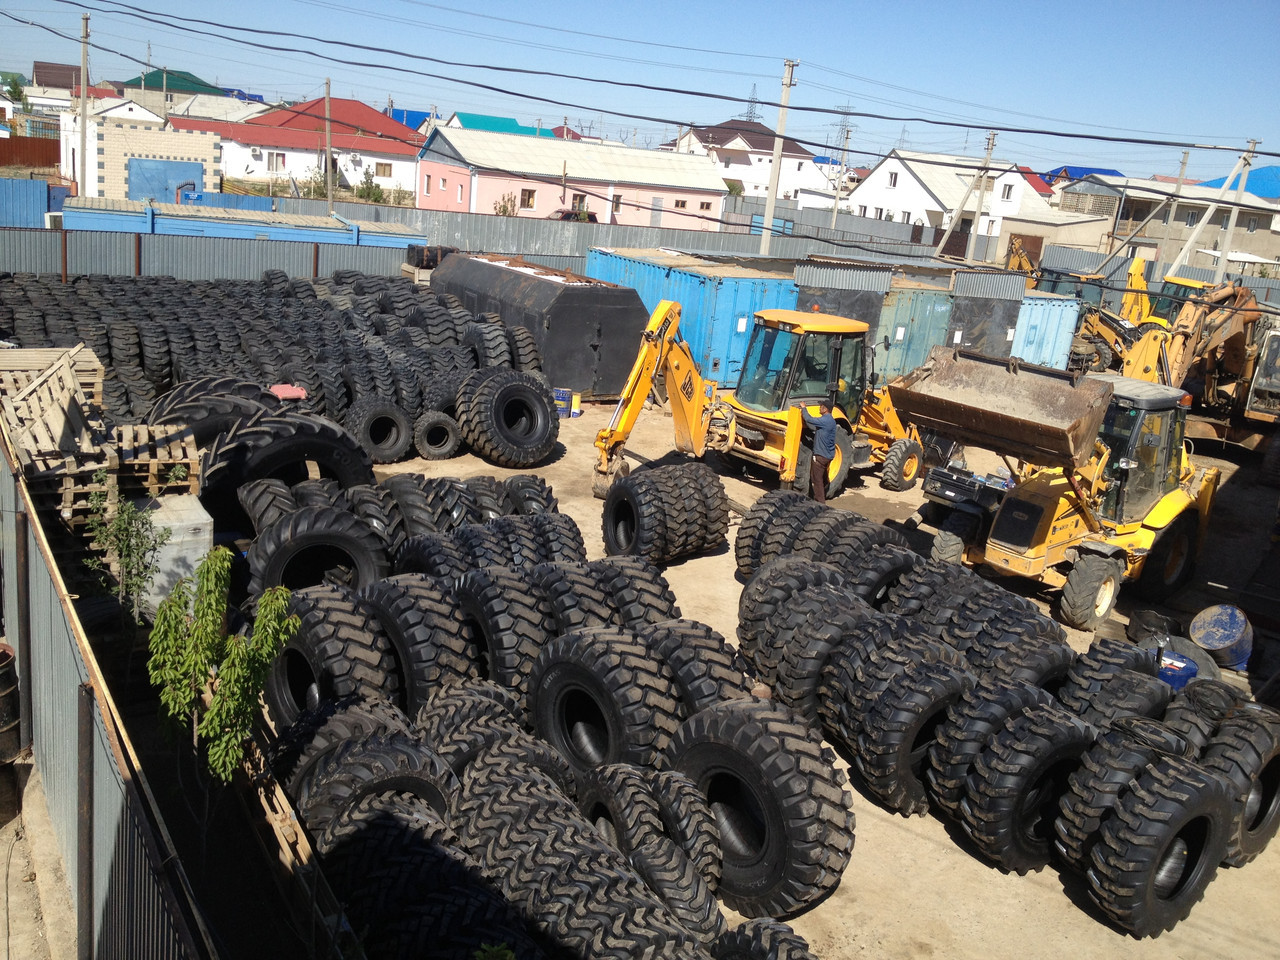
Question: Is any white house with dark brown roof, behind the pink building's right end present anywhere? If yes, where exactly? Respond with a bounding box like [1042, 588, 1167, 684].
[663, 120, 833, 206]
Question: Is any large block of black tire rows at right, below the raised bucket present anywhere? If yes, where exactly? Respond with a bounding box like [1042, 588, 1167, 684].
[736, 504, 1280, 937]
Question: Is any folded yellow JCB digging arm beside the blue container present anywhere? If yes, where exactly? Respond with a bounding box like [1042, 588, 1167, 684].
[591, 300, 717, 498]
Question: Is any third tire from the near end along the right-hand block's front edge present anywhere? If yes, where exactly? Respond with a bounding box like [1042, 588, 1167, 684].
[960, 707, 1097, 876]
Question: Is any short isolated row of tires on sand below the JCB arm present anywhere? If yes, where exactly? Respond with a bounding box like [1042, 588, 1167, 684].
[602, 461, 728, 564]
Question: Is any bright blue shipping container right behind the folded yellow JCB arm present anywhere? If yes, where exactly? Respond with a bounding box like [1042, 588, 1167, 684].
[586, 247, 799, 388]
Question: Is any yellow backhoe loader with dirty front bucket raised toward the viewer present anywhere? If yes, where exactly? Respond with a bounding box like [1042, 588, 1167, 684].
[888, 347, 1219, 628]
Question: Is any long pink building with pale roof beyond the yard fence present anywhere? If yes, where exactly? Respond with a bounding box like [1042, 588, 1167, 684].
[417, 127, 728, 230]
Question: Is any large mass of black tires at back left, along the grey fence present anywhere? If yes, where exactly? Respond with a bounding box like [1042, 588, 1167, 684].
[0, 270, 558, 466]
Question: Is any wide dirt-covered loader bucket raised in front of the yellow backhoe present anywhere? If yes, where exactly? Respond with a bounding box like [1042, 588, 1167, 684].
[888, 347, 1111, 468]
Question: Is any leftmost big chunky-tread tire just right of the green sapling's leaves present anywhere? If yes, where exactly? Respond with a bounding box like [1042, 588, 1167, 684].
[262, 586, 399, 728]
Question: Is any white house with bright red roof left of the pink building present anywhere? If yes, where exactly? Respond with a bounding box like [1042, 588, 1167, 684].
[169, 97, 425, 191]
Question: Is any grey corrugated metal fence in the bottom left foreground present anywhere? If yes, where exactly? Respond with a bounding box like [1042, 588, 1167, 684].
[0, 450, 216, 960]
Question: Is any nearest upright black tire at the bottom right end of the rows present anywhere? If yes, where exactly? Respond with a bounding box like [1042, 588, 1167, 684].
[1088, 756, 1231, 938]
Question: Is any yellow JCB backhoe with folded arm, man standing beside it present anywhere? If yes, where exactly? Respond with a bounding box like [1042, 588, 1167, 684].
[591, 300, 923, 498]
